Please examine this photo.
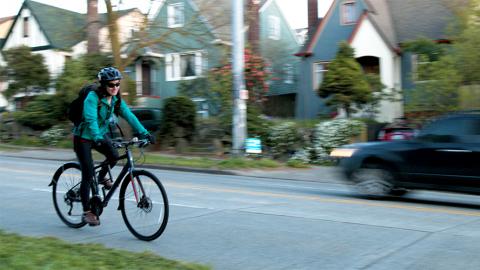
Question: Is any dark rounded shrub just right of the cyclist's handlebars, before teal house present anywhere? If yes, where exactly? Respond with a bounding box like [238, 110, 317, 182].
[160, 96, 196, 142]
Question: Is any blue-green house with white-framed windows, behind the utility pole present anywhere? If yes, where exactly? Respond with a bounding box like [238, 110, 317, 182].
[131, 0, 300, 116]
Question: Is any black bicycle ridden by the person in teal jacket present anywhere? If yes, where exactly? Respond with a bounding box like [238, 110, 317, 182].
[49, 138, 169, 241]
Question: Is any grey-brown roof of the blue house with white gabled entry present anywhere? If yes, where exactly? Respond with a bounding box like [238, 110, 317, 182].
[296, 0, 453, 56]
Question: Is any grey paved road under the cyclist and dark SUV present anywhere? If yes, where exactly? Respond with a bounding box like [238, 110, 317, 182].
[0, 156, 480, 270]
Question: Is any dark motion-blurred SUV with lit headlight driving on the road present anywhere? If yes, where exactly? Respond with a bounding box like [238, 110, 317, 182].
[331, 112, 480, 197]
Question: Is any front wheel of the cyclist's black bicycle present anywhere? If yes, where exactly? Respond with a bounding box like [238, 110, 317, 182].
[120, 170, 168, 241]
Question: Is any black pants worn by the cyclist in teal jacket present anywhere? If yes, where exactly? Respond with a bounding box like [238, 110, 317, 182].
[73, 136, 118, 211]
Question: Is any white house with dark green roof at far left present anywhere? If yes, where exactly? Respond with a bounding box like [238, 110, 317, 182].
[1, 0, 144, 79]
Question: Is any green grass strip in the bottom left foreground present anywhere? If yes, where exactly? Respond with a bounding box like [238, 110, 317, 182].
[0, 231, 210, 270]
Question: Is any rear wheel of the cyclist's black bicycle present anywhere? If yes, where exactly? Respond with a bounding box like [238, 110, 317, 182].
[52, 162, 86, 228]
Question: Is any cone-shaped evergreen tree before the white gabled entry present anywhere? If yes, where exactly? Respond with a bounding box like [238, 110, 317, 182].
[318, 41, 374, 117]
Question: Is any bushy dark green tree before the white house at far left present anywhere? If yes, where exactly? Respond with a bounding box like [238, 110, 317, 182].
[4, 46, 50, 98]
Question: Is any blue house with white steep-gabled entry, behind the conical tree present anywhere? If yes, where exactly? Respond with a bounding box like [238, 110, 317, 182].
[296, 0, 453, 122]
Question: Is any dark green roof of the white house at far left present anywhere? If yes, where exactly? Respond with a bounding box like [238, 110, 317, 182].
[5, 0, 141, 49]
